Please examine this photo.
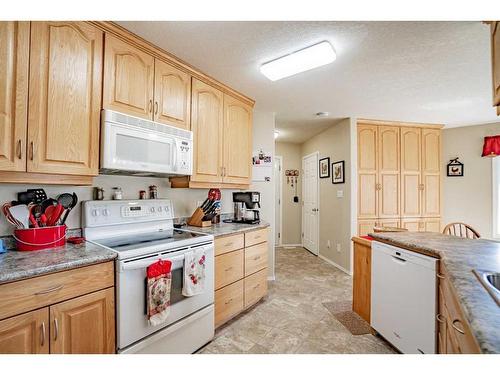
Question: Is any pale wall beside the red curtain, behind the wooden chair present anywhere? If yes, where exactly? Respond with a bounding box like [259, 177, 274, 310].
[442, 123, 500, 238]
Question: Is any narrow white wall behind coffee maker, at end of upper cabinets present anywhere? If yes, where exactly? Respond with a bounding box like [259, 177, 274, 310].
[250, 110, 275, 278]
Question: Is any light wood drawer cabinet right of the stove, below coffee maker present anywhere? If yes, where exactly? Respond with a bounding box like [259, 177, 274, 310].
[215, 228, 269, 327]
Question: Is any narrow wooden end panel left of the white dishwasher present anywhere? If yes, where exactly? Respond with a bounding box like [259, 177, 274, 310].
[352, 237, 372, 323]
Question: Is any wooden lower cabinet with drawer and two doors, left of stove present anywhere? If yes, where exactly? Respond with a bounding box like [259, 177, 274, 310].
[0, 262, 115, 354]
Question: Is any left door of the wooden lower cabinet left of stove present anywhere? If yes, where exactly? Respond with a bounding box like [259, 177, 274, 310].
[0, 308, 49, 354]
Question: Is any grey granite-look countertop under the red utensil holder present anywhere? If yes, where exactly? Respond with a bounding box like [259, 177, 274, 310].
[0, 242, 116, 284]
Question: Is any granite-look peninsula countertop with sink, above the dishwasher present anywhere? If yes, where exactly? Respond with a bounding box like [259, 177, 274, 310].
[370, 232, 500, 353]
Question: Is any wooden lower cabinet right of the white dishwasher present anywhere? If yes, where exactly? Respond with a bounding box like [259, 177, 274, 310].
[436, 262, 481, 354]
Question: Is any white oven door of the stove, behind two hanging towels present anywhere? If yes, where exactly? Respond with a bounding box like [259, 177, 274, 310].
[116, 243, 214, 349]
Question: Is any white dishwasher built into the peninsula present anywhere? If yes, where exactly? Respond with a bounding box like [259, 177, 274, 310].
[371, 241, 437, 354]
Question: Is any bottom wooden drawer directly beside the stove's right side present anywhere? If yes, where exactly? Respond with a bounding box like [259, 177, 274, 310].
[215, 280, 243, 327]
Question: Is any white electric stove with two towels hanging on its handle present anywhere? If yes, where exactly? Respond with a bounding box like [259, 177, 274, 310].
[82, 199, 214, 353]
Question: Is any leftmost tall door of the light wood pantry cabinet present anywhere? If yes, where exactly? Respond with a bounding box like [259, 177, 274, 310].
[358, 125, 378, 219]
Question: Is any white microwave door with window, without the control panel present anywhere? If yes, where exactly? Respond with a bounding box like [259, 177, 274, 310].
[101, 122, 178, 175]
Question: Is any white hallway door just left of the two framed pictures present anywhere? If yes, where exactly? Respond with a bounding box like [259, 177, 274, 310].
[302, 152, 319, 255]
